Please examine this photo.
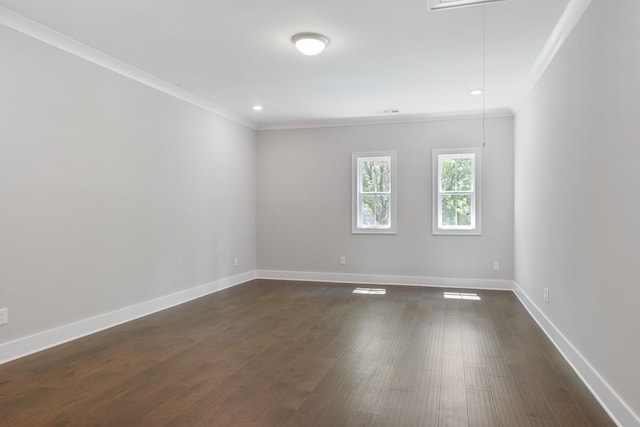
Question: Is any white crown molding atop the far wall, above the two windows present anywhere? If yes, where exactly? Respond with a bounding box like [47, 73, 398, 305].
[256, 108, 513, 130]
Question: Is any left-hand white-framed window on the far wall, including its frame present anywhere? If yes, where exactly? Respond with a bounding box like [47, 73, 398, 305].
[352, 152, 396, 234]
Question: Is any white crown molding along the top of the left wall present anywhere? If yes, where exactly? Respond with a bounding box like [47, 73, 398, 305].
[0, 6, 255, 129]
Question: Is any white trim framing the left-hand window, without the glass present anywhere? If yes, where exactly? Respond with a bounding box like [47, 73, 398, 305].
[351, 151, 398, 234]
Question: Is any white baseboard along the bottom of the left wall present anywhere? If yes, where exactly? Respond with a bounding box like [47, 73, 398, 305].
[0, 271, 256, 364]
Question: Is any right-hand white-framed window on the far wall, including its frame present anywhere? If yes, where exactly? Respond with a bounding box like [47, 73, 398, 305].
[433, 148, 481, 235]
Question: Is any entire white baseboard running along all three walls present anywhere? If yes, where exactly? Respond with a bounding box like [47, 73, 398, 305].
[0, 270, 640, 426]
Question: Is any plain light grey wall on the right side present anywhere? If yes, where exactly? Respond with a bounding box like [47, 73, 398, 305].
[515, 0, 640, 426]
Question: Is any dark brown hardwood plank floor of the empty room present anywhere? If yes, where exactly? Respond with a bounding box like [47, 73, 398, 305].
[0, 280, 613, 427]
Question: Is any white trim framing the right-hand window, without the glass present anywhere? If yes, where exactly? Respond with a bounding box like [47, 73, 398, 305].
[431, 147, 482, 236]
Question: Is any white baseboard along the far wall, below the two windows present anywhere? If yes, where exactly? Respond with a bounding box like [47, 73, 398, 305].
[256, 270, 513, 291]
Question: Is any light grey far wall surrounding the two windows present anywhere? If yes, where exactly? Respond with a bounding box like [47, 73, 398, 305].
[257, 118, 513, 286]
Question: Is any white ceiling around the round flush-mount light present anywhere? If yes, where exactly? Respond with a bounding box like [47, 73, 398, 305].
[0, 0, 569, 128]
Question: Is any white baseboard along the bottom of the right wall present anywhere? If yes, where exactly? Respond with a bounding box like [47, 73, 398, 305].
[513, 281, 640, 427]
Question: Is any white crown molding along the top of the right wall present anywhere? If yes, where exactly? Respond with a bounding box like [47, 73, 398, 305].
[514, 0, 591, 112]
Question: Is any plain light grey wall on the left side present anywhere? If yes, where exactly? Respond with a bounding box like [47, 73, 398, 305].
[0, 26, 255, 344]
